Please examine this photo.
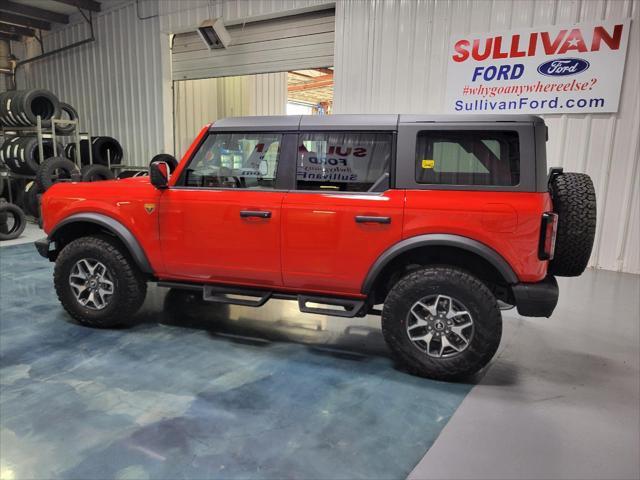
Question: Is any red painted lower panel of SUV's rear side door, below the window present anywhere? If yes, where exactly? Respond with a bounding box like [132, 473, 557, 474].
[282, 190, 404, 295]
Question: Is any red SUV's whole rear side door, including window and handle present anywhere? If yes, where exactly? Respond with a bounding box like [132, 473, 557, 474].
[282, 129, 404, 295]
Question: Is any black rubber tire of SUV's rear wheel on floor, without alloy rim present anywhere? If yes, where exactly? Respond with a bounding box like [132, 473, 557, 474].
[382, 267, 502, 380]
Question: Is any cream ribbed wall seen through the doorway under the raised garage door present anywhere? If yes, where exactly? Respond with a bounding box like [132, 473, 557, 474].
[174, 73, 287, 157]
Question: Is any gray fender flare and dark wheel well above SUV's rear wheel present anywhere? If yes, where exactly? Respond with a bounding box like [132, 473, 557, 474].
[361, 234, 519, 304]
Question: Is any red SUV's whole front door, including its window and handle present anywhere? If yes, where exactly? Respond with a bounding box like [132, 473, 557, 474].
[160, 132, 292, 287]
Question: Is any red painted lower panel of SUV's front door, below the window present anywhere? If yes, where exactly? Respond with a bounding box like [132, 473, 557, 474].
[160, 188, 284, 287]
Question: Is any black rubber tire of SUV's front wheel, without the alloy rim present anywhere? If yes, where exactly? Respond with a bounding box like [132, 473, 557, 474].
[53, 235, 147, 328]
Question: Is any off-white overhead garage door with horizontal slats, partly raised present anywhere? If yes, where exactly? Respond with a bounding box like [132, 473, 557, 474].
[171, 10, 335, 80]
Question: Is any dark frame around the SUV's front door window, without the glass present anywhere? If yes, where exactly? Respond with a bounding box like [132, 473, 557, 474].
[169, 130, 297, 192]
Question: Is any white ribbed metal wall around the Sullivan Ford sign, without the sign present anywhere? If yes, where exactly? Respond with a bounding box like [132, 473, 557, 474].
[334, 0, 640, 273]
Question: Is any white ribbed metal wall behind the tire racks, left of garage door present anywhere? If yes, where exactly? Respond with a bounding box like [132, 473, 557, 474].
[18, 2, 163, 165]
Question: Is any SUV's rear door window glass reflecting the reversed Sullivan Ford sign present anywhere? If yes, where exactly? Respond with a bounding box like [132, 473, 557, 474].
[296, 132, 393, 192]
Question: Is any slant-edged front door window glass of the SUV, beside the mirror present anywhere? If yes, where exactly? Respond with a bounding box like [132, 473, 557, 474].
[179, 132, 282, 190]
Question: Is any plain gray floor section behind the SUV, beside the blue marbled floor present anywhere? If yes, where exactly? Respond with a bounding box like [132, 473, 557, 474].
[409, 270, 640, 479]
